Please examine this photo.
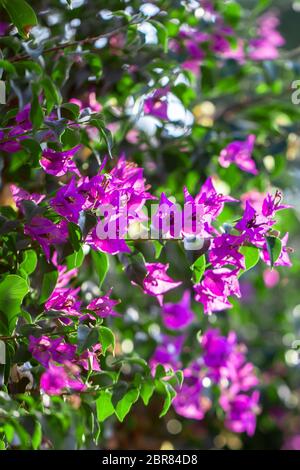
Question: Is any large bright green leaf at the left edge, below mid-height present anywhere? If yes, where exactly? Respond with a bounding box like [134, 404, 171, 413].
[0, 274, 29, 334]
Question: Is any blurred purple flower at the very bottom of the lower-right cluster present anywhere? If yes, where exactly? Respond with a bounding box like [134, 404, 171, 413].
[220, 391, 259, 436]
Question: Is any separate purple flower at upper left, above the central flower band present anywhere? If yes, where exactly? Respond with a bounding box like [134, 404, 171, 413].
[40, 145, 81, 176]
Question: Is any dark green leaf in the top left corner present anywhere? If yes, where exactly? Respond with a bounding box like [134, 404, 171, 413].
[1, 0, 38, 38]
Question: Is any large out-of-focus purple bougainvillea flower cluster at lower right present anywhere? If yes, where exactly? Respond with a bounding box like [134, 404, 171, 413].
[152, 329, 259, 436]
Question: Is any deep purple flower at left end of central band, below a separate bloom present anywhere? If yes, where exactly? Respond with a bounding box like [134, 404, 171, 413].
[50, 177, 85, 223]
